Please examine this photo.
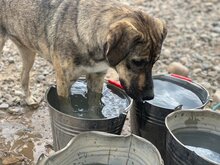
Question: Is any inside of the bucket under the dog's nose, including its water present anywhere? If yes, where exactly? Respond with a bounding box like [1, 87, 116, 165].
[147, 75, 209, 109]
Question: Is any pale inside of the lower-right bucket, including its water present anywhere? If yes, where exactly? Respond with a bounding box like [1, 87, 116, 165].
[166, 110, 220, 164]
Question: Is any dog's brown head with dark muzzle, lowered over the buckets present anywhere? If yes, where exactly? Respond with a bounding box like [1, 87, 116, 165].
[104, 12, 167, 100]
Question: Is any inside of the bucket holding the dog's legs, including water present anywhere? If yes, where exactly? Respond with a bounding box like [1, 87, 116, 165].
[46, 79, 132, 119]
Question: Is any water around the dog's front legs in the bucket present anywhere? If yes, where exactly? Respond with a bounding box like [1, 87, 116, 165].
[60, 79, 129, 119]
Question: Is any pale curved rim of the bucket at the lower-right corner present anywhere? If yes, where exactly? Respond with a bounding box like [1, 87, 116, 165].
[165, 109, 220, 165]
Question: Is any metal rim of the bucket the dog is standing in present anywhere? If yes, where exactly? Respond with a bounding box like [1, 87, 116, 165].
[45, 82, 133, 121]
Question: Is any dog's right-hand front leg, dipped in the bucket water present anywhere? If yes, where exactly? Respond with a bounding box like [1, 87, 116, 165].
[86, 72, 105, 117]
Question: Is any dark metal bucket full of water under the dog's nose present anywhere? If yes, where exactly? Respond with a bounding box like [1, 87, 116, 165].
[131, 75, 209, 160]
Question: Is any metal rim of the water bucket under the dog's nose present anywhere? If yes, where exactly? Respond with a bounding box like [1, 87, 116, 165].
[144, 74, 211, 111]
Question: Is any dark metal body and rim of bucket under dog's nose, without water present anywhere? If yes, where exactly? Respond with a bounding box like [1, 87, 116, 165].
[130, 75, 209, 163]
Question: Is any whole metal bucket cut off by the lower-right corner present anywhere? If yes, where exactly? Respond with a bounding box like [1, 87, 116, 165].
[165, 110, 220, 165]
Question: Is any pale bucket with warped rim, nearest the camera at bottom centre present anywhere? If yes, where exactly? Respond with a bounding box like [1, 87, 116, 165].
[37, 131, 163, 165]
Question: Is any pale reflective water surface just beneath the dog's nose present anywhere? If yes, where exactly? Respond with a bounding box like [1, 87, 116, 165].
[147, 79, 203, 109]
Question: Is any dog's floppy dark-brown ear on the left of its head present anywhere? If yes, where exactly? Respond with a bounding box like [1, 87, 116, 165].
[104, 21, 142, 66]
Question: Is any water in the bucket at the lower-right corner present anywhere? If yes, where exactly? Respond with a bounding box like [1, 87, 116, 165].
[173, 130, 220, 163]
